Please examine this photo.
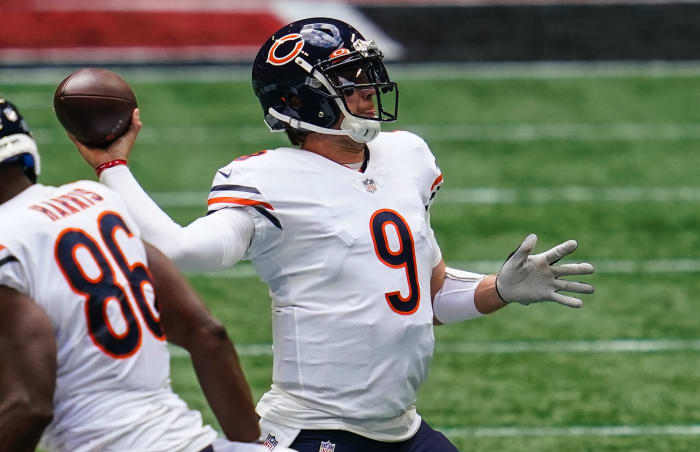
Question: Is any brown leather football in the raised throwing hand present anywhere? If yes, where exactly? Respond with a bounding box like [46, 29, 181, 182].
[53, 68, 137, 147]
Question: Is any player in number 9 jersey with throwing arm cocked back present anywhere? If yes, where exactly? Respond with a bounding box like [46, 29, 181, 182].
[69, 18, 593, 452]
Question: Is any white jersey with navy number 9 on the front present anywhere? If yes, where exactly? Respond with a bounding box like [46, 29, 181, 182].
[208, 132, 442, 440]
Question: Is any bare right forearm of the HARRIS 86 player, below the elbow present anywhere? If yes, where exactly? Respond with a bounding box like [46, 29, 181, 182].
[189, 325, 260, 441]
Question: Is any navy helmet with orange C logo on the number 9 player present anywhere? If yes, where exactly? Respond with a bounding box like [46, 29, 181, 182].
[253, 17, 399, 143]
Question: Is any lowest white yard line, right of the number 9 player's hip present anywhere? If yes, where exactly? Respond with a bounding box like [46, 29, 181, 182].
[438, 425, 700, 438]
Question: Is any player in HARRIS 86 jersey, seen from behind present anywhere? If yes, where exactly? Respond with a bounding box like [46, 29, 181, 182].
[0, 99, 298, 452]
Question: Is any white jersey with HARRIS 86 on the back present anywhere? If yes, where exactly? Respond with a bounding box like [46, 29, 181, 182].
[0, 181, 217, 452]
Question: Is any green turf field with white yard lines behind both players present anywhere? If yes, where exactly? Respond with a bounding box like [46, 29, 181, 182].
[5, 65, 700, 452]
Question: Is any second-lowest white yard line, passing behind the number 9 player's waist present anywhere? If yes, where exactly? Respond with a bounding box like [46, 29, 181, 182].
[169, 339, 700, 358]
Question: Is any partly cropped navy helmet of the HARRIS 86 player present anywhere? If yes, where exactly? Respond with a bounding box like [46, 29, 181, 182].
[0, 98, 41, 182]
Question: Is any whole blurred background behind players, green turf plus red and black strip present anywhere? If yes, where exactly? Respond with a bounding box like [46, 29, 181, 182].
[0, 0, 700, 452]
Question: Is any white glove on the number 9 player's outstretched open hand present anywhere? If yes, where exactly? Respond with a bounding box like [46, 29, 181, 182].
[496, 234, 594, 308]
